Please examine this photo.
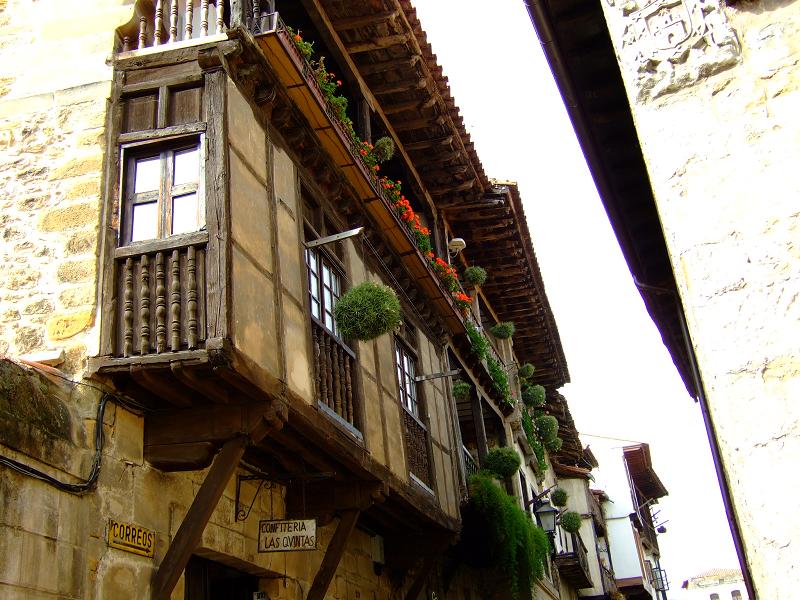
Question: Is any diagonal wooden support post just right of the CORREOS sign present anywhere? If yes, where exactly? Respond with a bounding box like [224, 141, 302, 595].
[152, 435, 248, 600]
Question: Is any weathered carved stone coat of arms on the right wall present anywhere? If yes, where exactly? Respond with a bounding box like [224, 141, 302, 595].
[606, 0, 741, 100]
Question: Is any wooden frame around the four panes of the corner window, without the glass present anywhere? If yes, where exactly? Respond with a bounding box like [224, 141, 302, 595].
[117, 132, 207, 247]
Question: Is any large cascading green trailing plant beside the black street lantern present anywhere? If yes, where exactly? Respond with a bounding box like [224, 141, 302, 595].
[460, 472, 550, 598]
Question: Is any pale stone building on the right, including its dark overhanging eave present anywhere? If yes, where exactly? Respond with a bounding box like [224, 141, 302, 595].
[532, 0, 800, 598]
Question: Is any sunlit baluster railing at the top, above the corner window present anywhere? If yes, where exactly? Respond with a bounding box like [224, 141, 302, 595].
[117, 0, 229, 52]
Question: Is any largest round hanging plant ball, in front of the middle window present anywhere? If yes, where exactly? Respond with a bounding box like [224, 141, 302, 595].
[333, 281, 400, 341]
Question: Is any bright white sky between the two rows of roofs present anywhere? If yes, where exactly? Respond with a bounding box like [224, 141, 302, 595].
[412, 0, 738, 599]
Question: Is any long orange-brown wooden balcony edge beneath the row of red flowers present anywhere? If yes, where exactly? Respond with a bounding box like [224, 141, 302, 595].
[255, 13, 464, 334]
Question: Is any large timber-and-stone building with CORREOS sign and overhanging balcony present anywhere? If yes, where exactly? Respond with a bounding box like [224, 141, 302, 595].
[0, 0, 624, 600]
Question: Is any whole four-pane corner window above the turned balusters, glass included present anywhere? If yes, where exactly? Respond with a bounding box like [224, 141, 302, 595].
[121, 138, 205, 245]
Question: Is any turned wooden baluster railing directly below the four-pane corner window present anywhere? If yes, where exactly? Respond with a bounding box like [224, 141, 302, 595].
[113, 232, 208, 357]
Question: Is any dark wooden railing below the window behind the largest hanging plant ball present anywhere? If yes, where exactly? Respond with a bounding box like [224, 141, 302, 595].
[311, 319, 359, 430]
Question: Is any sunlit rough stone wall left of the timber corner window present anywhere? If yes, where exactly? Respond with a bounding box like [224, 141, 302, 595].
[0, 0, 132, 373]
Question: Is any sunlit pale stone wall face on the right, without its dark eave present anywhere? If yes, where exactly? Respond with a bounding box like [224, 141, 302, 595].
[605, 0, 800, 598]
